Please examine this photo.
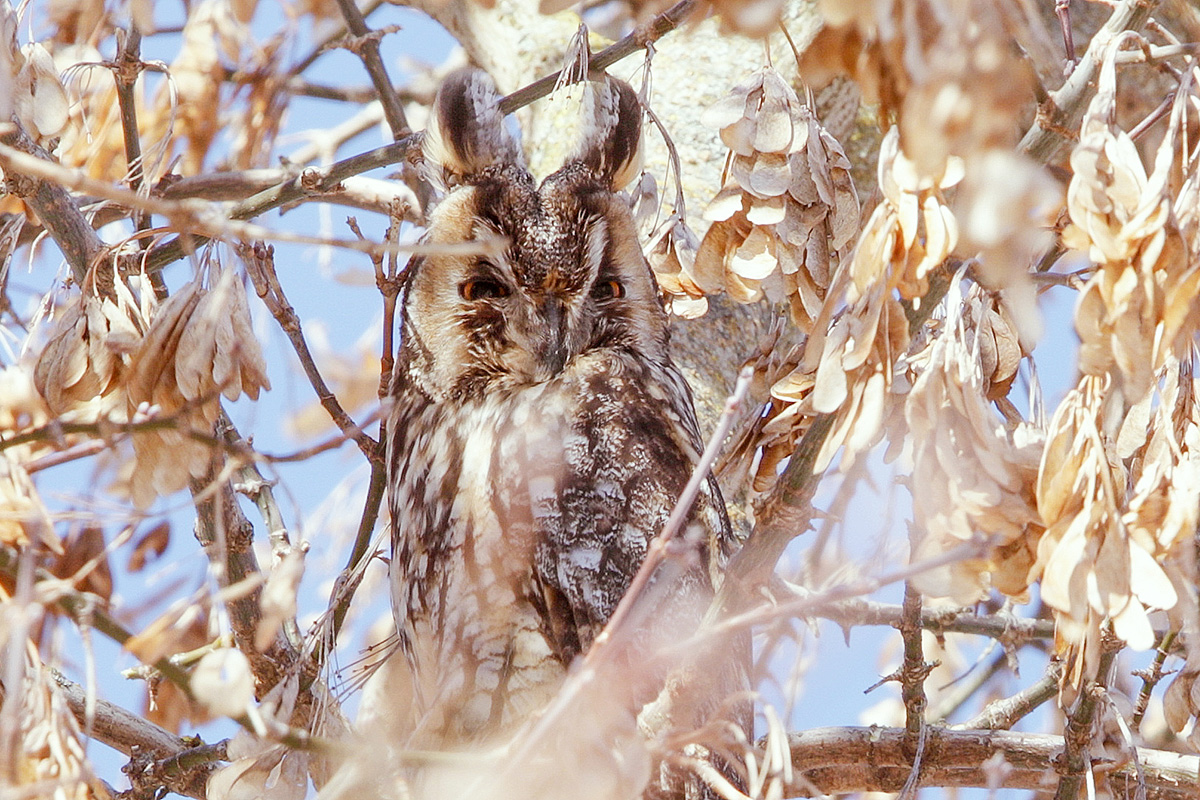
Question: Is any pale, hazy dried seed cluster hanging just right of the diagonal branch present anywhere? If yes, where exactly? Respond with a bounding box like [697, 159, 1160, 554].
[905, 285, 1044, 606]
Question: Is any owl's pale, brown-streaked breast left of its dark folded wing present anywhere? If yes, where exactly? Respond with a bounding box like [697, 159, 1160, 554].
[389, 398, 565, 746]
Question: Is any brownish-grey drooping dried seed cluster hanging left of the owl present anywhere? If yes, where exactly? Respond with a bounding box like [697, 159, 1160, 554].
[35, 267, 270, 507]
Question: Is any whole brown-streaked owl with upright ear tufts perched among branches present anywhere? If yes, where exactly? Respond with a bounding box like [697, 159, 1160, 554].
[386, 71, 737, 795]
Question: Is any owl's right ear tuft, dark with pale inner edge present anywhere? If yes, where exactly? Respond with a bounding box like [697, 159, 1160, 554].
[572, 76, 642, 191]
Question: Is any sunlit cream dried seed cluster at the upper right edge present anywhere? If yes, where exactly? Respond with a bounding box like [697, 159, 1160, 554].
[1063, 37, 1200, 403]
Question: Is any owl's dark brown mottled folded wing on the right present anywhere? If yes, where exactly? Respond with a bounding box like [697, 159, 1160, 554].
[511, 357, 728, 663]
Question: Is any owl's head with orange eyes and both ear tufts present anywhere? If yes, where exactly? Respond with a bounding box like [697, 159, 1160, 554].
[397, 70, 667, 398]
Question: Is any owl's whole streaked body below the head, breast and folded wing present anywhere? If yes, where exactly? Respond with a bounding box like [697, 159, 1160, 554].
[389, 351, 726, 745]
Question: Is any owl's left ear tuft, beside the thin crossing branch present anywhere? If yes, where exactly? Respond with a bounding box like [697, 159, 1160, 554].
[425, 67, 523, 186]
